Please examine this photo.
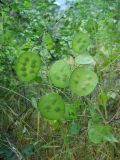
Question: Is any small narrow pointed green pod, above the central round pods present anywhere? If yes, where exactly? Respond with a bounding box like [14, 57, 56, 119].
[43, 33, 54, 49]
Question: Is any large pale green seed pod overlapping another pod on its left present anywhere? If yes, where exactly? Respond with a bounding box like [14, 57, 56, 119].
[70, 67, 98, 96]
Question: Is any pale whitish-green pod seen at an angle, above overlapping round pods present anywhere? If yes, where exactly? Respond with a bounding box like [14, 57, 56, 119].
[75, 54, 95, 64]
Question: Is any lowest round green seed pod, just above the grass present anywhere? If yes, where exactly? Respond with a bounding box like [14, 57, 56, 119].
[38, 93, 65, 120]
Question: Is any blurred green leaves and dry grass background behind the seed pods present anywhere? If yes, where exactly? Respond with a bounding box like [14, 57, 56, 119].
[0, 0, 120, 160]
